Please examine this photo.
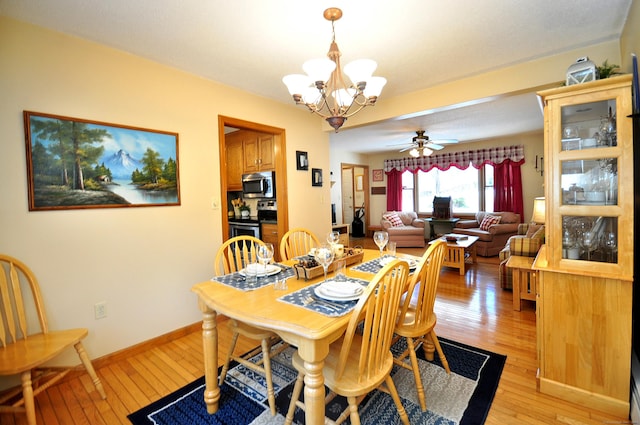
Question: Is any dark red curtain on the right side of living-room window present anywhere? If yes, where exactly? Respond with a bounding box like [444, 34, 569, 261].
[493, 159, 524, 222]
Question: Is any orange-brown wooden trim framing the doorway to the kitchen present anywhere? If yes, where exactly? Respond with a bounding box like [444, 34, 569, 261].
[218, 115, 289, 241]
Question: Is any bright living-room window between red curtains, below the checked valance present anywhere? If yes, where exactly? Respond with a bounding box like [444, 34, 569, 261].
[402, 165, 494, 214]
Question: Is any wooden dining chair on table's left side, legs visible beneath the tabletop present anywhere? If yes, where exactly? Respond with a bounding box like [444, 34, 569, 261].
[213, 236, 288, 415]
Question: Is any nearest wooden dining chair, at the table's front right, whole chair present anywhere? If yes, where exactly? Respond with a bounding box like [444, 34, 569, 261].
[285, 260, 409, 425]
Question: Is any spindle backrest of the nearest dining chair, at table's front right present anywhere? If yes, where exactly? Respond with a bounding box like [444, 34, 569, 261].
[335, 260, 409, 382]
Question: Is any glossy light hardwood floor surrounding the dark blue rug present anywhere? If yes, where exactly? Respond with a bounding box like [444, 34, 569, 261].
[5, 239, 628, 425]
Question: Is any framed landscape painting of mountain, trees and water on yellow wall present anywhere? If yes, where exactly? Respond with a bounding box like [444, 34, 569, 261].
[24, 111, 180, 211]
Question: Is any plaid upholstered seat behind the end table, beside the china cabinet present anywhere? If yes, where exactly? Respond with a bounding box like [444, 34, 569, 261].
[499, 223, 545, 289]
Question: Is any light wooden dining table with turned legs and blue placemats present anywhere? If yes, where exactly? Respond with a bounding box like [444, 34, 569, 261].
[192, 249, 416, 425]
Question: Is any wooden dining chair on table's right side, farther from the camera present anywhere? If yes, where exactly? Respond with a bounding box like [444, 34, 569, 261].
[394, 239, 451, 411]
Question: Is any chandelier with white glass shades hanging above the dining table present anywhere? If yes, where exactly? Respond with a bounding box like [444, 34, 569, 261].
[282, 7, 387, 132]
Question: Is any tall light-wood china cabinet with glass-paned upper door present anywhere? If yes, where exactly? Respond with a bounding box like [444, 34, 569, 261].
[533, 75, 634, 416]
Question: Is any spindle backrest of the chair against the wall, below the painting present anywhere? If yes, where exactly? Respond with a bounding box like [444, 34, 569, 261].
[0, 254, 49, 347]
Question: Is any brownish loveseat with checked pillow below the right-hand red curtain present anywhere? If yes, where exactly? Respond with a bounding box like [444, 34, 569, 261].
[453, 211, 520, 257]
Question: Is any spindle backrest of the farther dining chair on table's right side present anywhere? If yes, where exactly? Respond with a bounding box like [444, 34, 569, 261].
[398, 239, 447, 326]
